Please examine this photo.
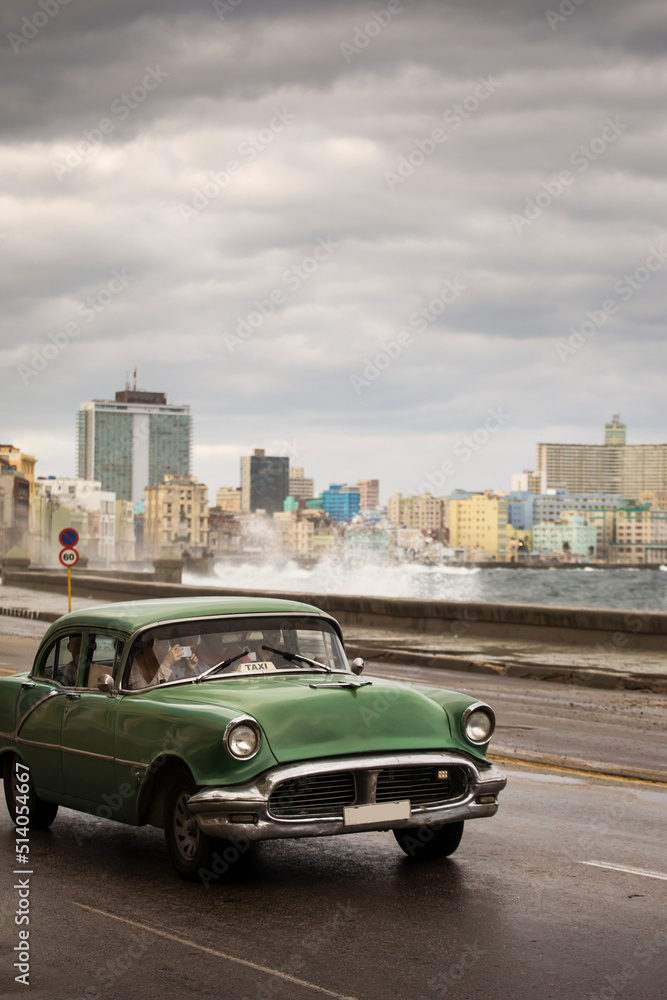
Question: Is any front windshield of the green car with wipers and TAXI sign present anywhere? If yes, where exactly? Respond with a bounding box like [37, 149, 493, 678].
[123, 615, 350, 691]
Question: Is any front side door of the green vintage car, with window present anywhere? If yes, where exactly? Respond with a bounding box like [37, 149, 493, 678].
[62, 631, 123, 817]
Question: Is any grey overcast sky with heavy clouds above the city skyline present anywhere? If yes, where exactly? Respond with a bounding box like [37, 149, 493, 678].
[0, 0, 667, 500]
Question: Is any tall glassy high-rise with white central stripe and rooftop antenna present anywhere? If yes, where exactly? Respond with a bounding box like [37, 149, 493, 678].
[77, 388, 192, 503]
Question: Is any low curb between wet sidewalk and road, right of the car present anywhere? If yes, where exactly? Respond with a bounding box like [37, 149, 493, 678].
[346, 641, 667, 694]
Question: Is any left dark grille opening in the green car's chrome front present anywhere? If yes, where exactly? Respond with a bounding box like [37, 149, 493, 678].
[269, 771, 355, 819]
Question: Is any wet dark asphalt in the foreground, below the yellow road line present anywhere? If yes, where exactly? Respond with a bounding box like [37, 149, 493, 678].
[0, 770, 667, 1000]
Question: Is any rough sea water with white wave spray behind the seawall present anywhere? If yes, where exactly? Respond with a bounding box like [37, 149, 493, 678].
[183, 554, 667, 611]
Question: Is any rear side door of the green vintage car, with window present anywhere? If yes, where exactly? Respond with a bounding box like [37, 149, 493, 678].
[16, 631, 83, 797]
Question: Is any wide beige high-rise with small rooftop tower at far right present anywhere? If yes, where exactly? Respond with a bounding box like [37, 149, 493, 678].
[537, 415, 667, 500]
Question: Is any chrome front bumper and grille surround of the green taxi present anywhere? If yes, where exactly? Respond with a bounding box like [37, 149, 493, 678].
[189, 752, 507, 841]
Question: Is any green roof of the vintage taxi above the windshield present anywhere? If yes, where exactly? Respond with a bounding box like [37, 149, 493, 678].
[47, 597, 329, 634]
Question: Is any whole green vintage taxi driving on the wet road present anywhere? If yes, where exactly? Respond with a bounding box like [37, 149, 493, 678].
[0, 597, 506, 881]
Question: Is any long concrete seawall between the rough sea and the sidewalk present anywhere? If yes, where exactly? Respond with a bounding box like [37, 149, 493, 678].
[3, 569, 667, 651]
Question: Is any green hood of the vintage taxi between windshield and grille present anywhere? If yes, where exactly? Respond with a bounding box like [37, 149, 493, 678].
[159, 674, 457, 763]
